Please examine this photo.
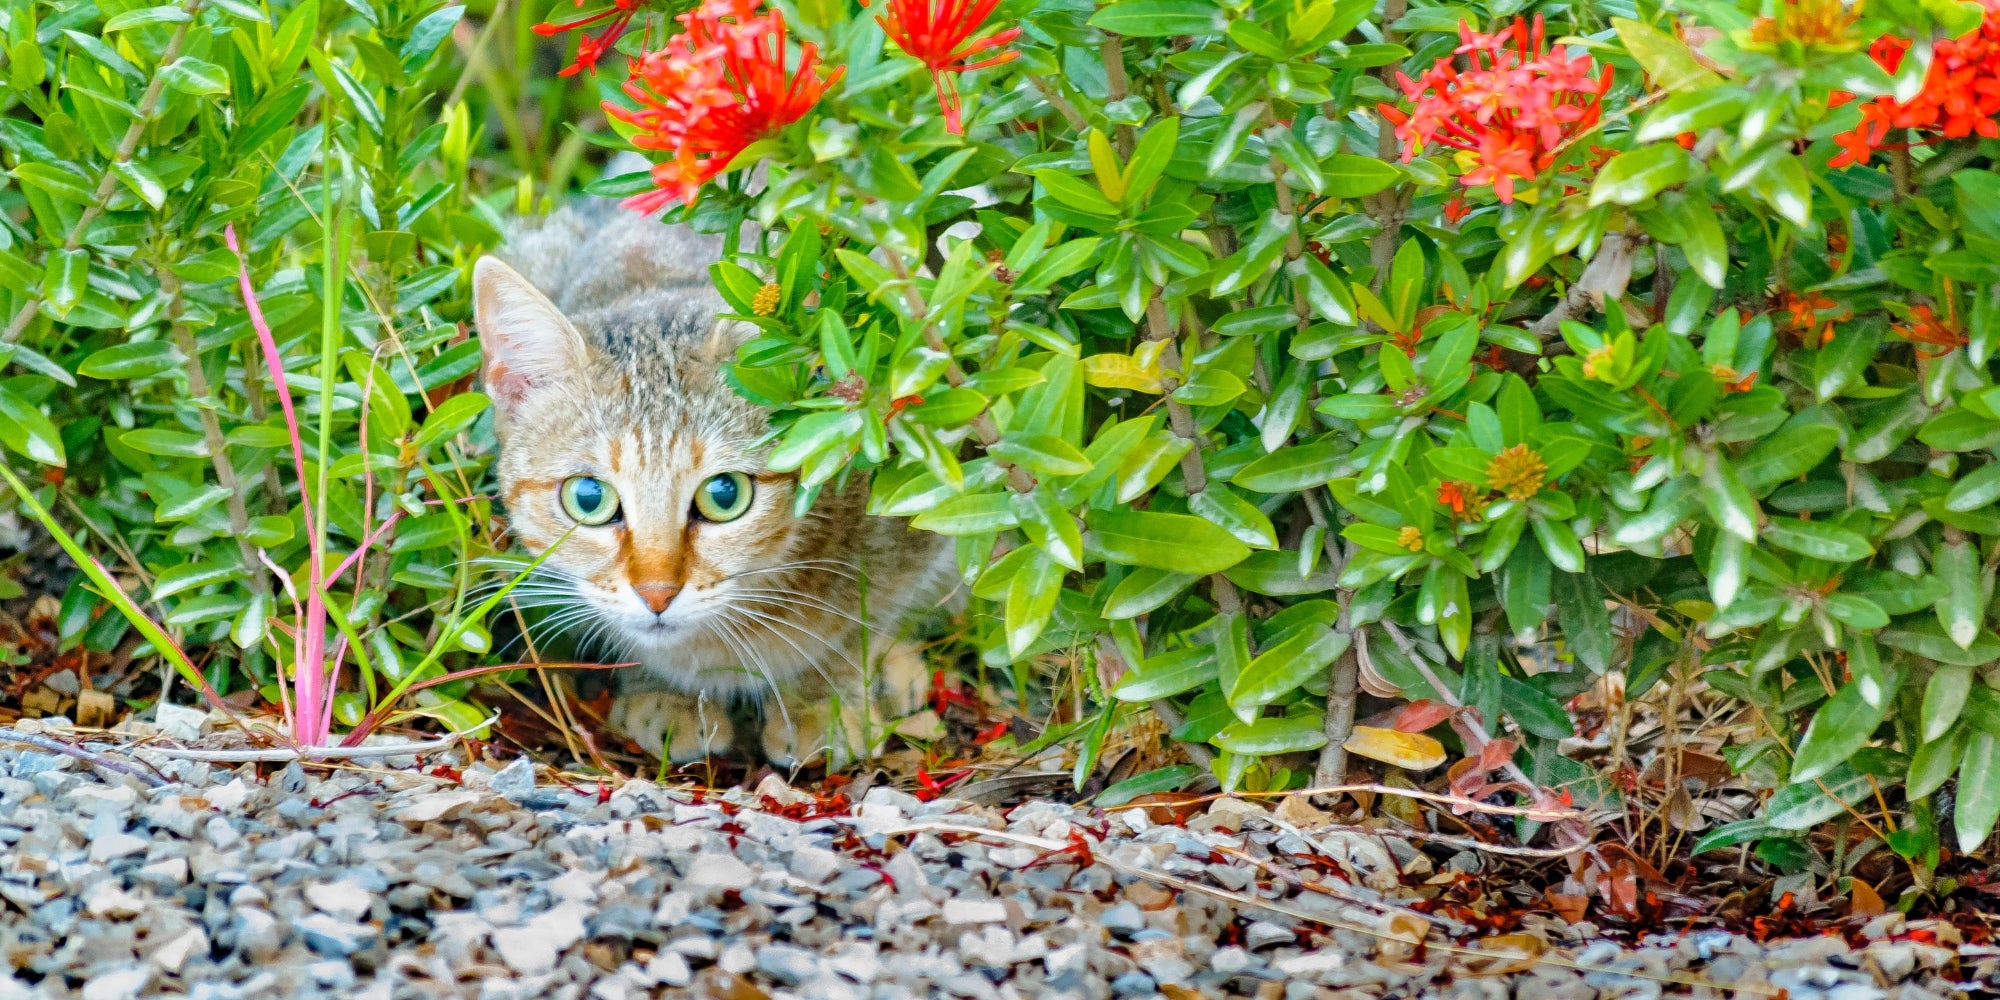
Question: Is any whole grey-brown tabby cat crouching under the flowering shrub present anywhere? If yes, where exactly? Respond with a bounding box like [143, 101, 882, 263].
[472, 202, 956, 766]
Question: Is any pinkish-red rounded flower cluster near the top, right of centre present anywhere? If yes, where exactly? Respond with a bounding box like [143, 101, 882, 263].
[1380, 14, 1612, 202]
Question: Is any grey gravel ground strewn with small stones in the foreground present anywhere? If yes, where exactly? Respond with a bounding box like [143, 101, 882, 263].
[0, 748, 2000, 1000]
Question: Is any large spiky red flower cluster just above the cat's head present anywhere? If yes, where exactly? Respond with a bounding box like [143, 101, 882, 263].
[604, 0, 842, 212]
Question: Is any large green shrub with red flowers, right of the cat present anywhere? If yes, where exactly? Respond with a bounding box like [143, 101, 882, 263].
[598, 0, 2000, 876]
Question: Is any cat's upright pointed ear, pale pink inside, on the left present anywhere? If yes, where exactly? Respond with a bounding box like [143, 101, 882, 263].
[472, 256, 584, 422]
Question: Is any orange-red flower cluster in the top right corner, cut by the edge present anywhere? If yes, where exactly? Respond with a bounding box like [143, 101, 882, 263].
[1828, 0, 2000, 166]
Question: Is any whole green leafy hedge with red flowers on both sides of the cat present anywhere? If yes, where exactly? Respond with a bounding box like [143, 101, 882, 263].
[19, 0, 2000, 884]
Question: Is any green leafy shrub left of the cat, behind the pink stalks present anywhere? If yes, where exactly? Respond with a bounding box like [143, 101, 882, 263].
[0, 0, 594, 742]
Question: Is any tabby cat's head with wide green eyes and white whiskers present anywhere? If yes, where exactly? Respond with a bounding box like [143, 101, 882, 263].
[474, 258, 860, 688]
